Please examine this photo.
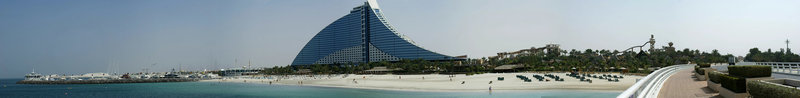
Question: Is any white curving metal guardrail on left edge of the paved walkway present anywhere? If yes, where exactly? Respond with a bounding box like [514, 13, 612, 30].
[617, 64, 694, 98]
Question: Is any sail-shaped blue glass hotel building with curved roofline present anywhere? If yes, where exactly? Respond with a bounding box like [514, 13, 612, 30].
[292, 0, 463, 65]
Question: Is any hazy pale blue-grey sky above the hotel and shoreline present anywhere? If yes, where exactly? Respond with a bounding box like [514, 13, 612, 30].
[0, 0, 800, 78]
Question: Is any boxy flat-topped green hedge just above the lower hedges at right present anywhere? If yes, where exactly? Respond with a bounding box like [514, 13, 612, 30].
[728, 65, 772, 78]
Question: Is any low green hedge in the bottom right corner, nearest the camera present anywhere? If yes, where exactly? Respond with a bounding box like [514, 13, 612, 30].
[747, 81, 800, 98]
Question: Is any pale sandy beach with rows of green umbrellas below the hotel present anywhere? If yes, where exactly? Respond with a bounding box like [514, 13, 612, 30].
[201, 73, 642, 91]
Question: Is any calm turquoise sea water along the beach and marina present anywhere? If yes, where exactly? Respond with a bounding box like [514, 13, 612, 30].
[0, 79, 621, 98]
